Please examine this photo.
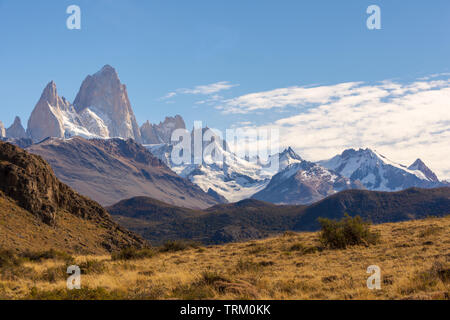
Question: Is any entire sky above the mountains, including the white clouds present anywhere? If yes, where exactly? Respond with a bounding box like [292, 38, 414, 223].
[0, 0, 450, 179]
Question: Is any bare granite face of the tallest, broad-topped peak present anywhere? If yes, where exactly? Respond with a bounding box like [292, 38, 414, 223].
[74, 65, 141, 142]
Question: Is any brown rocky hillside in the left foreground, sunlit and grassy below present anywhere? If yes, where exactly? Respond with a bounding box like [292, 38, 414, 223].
[0, 142, 145, 253]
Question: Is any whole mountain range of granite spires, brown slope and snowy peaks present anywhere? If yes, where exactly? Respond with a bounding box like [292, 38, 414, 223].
[0, 65, 449, 209]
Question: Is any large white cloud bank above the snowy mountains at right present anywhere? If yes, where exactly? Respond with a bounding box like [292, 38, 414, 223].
[218, 78, 450, 179]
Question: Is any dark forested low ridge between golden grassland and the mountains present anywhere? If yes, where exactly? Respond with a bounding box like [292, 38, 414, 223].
[108, 187, 450, 244]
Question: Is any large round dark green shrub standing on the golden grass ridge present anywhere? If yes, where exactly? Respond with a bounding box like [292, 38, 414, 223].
[319, 214, 380, 249]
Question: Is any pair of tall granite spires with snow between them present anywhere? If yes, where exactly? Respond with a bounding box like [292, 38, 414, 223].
[27, 65, 145, 142]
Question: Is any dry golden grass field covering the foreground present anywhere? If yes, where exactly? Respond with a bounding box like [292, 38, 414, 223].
[0, 216, 450, 300]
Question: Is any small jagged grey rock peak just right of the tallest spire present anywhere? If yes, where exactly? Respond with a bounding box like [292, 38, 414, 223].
[141, 115, 186, 144]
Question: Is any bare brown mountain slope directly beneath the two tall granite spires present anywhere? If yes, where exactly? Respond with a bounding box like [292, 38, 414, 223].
[27, 137, 221, 208]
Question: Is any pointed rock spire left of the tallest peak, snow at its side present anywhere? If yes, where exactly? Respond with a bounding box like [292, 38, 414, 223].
[27, 81, 70, 142]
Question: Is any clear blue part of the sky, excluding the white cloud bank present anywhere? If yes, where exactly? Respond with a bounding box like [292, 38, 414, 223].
[0, 0, 450, 177]
